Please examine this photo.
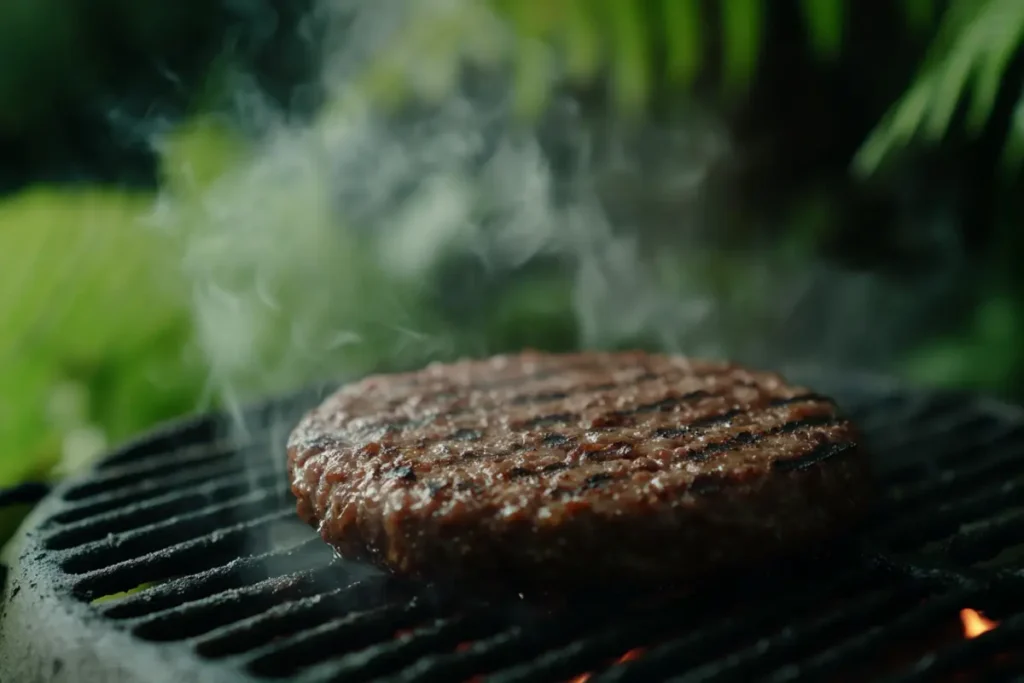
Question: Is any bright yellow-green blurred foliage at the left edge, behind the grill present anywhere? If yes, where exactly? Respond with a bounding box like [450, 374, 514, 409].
[0, 188, 201, 485]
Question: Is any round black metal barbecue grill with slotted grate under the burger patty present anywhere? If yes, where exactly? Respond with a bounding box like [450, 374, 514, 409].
[0, 371, 1024, 683]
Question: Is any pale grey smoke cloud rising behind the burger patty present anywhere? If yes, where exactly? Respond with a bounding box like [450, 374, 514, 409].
[153, 0, 966, 428]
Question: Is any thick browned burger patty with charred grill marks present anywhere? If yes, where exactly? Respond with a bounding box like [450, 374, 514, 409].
[289, 351, 868, 586]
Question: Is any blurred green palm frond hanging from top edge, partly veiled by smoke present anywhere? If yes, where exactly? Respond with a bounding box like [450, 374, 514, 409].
[344, 0, 940, 115]
